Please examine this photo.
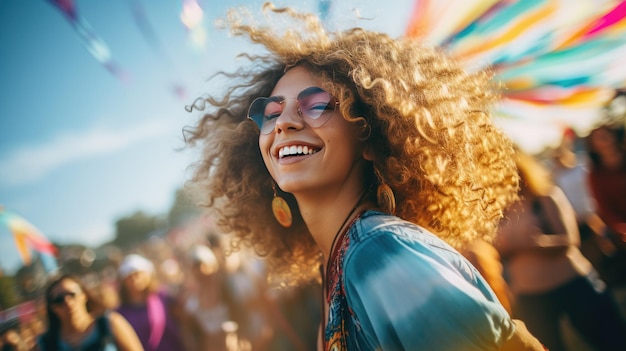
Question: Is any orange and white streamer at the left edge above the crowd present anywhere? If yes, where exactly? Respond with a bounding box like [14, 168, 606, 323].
[0, 206, 57, 265]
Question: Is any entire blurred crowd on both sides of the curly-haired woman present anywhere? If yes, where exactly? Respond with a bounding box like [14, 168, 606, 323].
[0, 121, 626, 351]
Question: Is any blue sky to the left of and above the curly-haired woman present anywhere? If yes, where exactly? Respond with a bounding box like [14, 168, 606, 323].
[0, 0, 413, 274]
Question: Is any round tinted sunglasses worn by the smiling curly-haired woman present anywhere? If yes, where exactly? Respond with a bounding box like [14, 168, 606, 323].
[248, 87, 339, 134]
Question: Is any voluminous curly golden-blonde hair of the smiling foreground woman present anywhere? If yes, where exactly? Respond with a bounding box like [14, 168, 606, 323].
[184, 4, 518, 282]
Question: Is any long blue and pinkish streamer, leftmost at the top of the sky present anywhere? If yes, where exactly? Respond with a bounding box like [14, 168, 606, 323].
[48, 0, 130, 81]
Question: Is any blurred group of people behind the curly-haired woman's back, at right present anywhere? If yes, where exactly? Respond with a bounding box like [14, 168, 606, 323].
[465, 125, 626, 351]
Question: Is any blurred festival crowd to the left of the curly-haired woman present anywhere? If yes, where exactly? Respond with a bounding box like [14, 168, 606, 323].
[0, 226, 321, 351]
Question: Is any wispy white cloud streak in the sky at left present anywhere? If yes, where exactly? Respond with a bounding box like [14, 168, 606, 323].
[0, 120, 171, 187]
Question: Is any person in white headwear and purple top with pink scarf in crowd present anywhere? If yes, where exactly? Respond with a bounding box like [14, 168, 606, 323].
[117, 254, 192, 351]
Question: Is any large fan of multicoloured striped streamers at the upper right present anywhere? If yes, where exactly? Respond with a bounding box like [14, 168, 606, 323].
[405, 0, 626, 152]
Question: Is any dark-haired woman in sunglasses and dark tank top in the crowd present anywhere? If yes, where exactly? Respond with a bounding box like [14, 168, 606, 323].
[37, 275, 143, 351]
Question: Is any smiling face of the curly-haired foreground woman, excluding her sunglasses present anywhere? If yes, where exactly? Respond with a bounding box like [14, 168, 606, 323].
[259, 66, 364, 196]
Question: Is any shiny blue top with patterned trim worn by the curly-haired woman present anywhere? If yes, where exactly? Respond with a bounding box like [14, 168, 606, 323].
[324, 211, 515, 351]
